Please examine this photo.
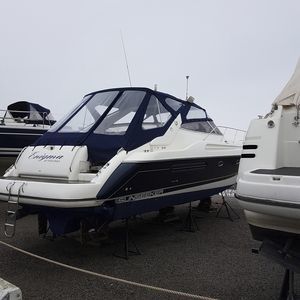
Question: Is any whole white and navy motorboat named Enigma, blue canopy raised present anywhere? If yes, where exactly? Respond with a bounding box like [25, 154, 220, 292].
[0, 87, 242, 235]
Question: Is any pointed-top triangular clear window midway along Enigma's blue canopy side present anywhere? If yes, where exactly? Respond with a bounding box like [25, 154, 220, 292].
[142, 96, 172, 130]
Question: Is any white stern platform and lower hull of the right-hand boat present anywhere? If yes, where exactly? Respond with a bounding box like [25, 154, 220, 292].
[236, 168, 300, 240]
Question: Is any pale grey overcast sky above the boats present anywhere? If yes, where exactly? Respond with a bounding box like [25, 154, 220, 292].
[0, 0, 300, 129]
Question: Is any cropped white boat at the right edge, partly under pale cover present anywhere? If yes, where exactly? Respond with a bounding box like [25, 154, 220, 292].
[236, 62, 300, 243]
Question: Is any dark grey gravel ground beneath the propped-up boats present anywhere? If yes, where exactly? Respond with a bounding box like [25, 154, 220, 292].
[0, 197, 300, 300]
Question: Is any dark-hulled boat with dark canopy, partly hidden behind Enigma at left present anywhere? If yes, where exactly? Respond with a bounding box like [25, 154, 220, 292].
[0, 101, 55, 175]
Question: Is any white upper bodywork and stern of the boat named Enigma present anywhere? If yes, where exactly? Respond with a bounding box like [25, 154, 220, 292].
[0, 125, 240, 208]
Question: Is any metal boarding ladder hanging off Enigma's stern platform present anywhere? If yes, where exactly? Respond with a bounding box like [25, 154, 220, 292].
[4, 182, 25, 238]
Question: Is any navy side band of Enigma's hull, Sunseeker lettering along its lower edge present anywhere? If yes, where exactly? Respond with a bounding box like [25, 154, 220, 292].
[97, 156, 240, 202]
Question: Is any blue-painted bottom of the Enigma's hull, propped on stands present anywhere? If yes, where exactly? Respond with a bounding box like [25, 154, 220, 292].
[20, 176, 236, 235]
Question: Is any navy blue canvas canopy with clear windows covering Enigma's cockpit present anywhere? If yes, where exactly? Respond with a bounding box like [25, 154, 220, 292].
[35, 88, 221, 166]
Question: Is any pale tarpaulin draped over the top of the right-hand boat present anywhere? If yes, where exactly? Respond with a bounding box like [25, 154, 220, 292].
[273, 59, 300, 106]
